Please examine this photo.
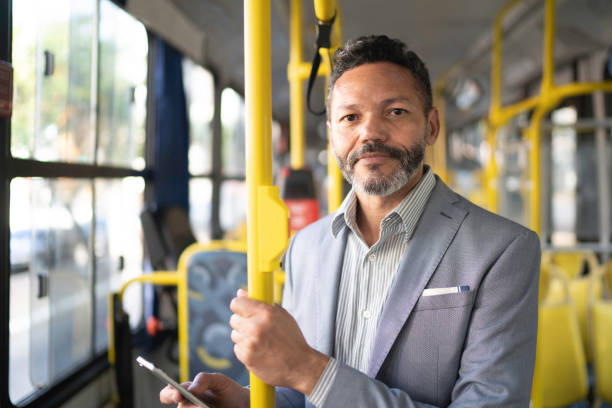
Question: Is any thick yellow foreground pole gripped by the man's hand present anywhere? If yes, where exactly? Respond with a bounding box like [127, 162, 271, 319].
[244, 0, 288, 408]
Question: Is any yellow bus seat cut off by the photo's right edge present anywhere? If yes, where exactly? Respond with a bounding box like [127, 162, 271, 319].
[592, 300, 612, 404]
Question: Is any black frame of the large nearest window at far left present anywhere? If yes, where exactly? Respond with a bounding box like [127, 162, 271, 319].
[0, 0, 155, 408]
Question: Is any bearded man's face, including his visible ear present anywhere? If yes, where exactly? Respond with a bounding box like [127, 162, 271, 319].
[328, 62, 439, 196]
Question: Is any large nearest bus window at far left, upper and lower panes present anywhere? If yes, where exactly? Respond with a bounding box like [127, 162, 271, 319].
[8, 0, 148, 404]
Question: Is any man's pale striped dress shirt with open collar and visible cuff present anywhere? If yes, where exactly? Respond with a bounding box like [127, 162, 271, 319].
[308, 166, 436, 406]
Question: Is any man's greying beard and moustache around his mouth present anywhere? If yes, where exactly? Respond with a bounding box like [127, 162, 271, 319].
[333, 138, 425, 197]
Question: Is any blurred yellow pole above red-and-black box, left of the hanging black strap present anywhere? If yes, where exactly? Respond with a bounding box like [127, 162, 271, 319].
[288, 0, 304, 169]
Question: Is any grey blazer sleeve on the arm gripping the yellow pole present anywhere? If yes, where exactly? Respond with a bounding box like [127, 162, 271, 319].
[322, 230, 540, 408]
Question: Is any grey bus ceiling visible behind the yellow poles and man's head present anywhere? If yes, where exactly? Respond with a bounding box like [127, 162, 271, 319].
[126, 0, 612, 140]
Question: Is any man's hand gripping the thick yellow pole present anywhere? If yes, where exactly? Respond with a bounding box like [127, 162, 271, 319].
[230, 289, 329, 395]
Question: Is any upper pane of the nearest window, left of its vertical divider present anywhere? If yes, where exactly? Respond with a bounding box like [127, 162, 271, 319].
[11, 0, 96, 162]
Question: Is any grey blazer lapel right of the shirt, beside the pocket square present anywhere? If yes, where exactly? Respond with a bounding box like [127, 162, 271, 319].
[368, 183, 467, 378]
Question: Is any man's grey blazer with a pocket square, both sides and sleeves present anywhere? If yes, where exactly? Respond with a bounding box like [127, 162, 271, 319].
[277, 179, 540, 408]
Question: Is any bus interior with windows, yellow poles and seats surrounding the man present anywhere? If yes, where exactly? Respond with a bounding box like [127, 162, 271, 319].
[0, 0, 612, 408]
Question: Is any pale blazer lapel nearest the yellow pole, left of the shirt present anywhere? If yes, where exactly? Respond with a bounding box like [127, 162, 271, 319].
[313, 226, 348, 356]
